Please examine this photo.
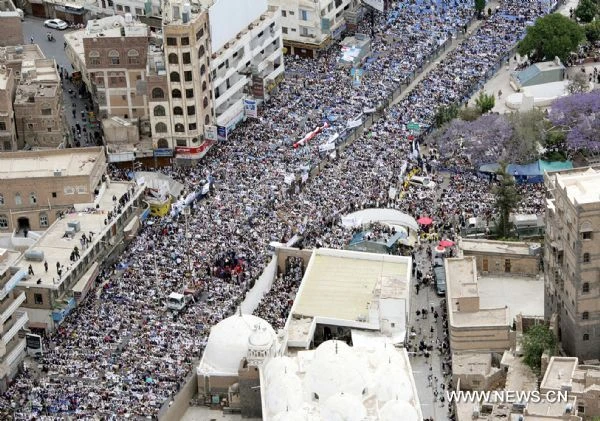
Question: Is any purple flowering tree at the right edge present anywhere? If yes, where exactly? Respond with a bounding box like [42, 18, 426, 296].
[548, 90, 600, 154]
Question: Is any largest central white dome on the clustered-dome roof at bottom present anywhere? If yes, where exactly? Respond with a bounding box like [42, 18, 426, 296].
[304, 341, 369, 402]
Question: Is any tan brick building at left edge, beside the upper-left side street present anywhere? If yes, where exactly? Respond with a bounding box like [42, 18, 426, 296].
[0, 44, 66, 150]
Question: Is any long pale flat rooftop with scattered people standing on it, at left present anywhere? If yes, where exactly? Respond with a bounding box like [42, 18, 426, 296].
[15, 182, 143, 289]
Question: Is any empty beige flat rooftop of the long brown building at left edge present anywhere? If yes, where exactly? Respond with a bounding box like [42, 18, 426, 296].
[0, 147, 104, 181]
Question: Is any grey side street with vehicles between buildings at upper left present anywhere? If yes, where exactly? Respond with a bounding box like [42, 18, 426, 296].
[23, 16, 93, 146]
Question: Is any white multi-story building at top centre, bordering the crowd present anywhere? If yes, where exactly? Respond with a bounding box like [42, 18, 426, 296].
[269, 0, 360, 57]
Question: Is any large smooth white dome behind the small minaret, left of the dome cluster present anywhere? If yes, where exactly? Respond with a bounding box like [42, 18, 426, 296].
[198, 314, 276, 375]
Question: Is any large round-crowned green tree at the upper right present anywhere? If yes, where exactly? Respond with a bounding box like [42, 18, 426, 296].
[518, 13, 585, 62]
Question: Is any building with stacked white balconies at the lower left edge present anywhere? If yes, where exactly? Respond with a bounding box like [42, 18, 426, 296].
[0, 249, 29, 393]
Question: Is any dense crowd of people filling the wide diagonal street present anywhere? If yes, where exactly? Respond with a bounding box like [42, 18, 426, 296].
[0, 0, 546, 420]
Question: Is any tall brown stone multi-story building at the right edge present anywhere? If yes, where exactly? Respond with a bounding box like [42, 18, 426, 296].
[544, 168, 600, 360]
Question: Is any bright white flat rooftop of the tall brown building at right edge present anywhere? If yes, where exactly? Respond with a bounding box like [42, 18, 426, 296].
[548, 167, 600, 205]
